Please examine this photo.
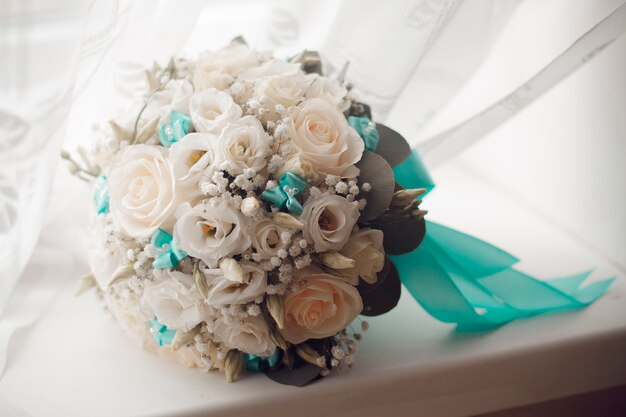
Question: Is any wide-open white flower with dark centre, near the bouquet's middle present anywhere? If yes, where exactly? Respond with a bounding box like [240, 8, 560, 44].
[174, 202, 250, 268]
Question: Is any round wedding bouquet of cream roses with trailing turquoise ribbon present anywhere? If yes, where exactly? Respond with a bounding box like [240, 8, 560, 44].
[63, 41, 608, 385]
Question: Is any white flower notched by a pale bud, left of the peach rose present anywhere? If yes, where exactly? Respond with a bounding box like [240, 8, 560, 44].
[205, 261, 267, 306]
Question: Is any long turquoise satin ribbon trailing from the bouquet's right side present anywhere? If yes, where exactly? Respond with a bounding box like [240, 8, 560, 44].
[390, 152, 614, 330]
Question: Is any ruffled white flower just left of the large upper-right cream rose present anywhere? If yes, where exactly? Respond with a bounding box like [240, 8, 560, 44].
[218, 116, 272, 175]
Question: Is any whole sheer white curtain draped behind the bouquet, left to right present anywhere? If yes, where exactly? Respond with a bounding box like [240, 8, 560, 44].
[0, 0, 623, 374]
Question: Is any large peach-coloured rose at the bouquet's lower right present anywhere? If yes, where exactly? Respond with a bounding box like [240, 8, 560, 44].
[282, 267, 363, 343]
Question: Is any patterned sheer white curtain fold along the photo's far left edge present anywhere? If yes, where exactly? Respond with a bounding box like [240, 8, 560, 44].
[0, 0, 89, 314]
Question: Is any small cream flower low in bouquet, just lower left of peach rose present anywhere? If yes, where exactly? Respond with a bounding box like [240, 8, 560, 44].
[213, 316, 276, 356]
